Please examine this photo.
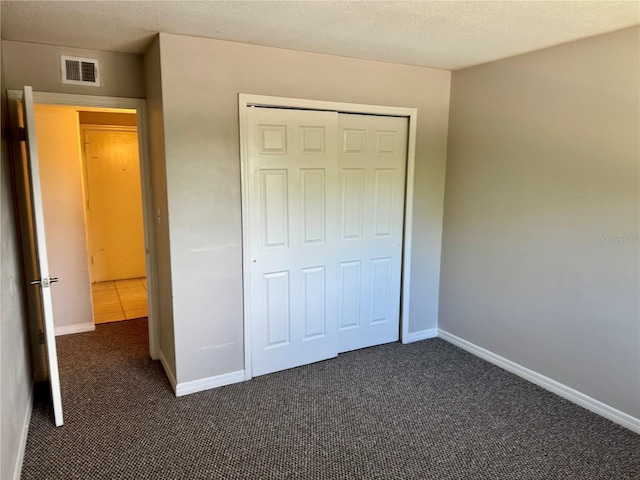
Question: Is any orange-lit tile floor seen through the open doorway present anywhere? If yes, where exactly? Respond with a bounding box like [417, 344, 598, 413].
[91, 278, 149, 324]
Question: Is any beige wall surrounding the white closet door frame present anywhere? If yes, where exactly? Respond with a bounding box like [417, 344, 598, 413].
[158, 34, 450, 382]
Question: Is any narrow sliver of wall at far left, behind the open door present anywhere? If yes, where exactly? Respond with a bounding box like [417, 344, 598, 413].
[0, 42, 32, 479]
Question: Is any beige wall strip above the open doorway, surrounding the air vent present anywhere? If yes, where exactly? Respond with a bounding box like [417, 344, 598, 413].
[2, 40, 145, 98]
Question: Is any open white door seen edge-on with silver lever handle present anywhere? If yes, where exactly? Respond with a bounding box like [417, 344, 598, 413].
[22, 87, 63, 426]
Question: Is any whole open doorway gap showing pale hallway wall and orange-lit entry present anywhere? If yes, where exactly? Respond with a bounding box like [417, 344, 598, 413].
[35, 104, 148, 328]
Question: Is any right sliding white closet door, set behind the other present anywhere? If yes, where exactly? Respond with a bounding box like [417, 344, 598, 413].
[338, 114, 408, 352]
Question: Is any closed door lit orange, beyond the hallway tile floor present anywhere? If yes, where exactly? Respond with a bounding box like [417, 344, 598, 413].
[82, 127, 146, 282]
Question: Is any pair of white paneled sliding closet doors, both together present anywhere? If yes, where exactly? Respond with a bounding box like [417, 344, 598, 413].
[246, 107, 408, 376]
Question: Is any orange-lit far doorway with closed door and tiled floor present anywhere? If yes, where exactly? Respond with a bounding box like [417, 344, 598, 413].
[78, 119, 148, 324]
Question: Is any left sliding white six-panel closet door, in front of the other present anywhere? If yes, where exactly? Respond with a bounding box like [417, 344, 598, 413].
[247, 107, 339, 376]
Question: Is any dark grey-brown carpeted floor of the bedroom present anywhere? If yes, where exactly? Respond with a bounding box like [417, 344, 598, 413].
[22, 319, 640, 480]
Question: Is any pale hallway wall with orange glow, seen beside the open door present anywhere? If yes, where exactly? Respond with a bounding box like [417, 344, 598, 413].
[35, 105, 94, 335]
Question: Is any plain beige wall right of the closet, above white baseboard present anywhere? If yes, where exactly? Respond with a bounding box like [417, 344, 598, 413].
[440, 28, 640, 418]
